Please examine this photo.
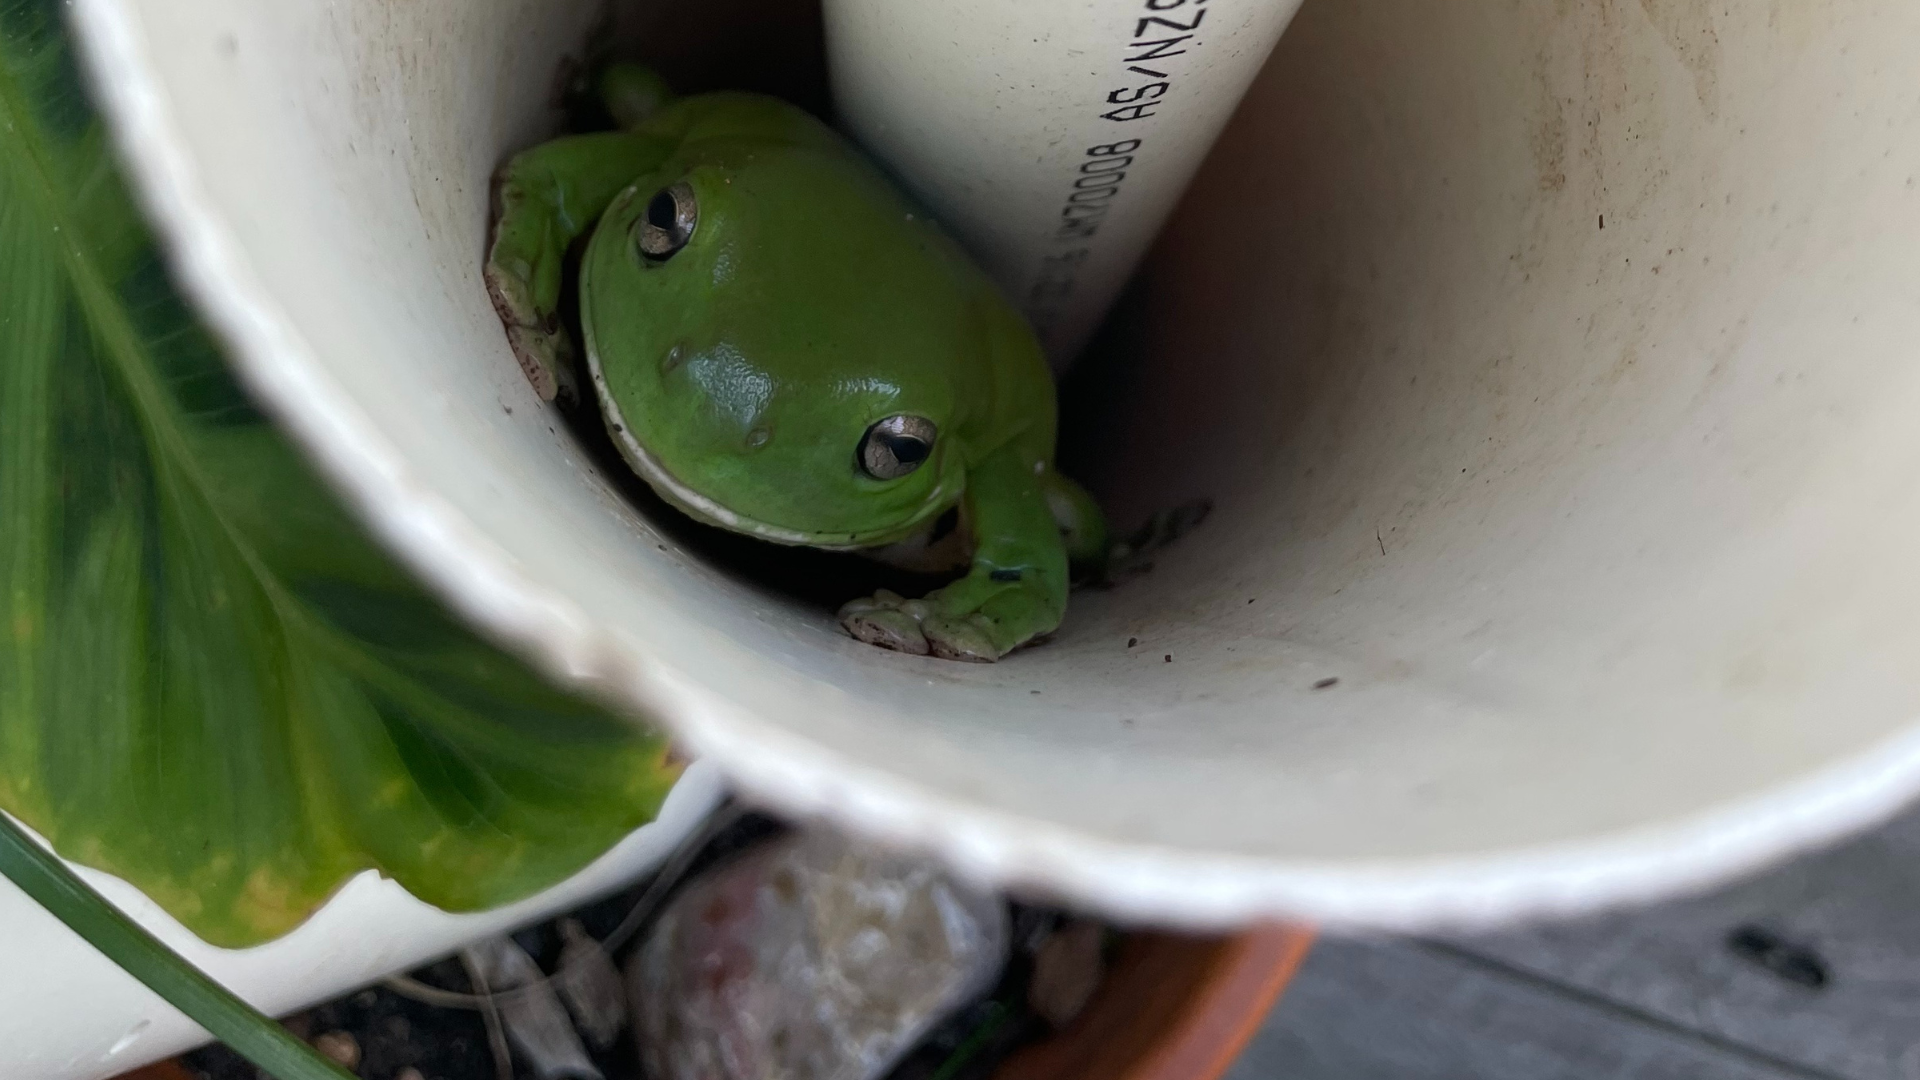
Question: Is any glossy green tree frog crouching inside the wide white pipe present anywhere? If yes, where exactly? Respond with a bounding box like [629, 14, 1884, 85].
[486, 65, 1106, 661]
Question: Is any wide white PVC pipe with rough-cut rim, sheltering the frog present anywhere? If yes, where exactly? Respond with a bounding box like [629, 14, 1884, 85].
[33, 0, 1920, 1060]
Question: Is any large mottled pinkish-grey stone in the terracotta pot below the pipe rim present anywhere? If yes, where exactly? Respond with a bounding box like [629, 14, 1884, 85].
[626, 830, 1012, 1080]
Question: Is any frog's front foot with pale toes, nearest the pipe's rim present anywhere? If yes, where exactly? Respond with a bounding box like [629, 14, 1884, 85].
[839, 582, 1060, 663]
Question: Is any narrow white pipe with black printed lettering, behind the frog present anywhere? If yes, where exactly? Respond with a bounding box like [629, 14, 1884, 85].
[826, 0, 1300, 371]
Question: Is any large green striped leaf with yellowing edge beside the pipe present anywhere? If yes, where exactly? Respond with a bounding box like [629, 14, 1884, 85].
[0, 0, 676, 945]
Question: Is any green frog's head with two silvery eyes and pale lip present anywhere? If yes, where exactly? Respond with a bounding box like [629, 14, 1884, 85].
[580, 134, 1004, 548]
